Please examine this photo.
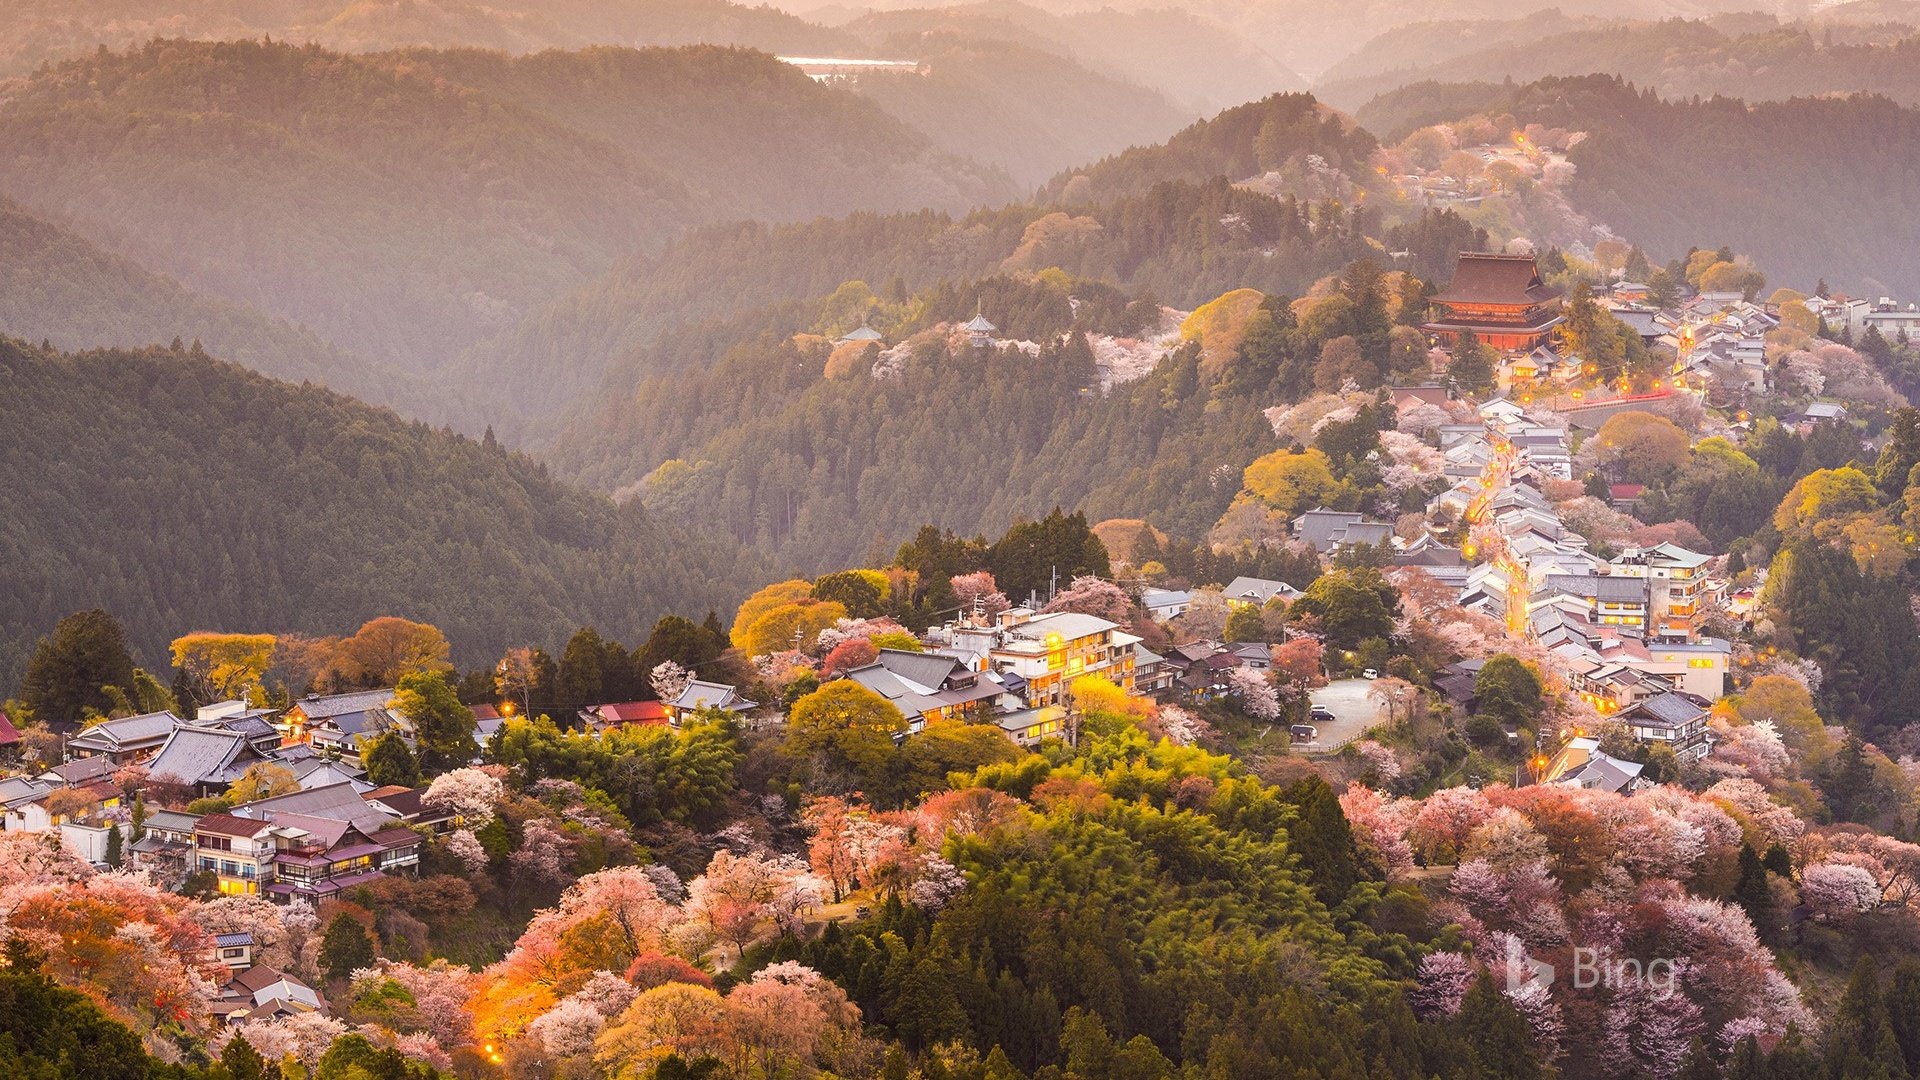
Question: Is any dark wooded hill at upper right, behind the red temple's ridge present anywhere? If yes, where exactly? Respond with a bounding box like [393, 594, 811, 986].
[1359, 75, 1920, 296]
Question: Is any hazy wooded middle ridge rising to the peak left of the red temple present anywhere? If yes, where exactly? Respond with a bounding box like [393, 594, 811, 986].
[453, 94, 1373, 440]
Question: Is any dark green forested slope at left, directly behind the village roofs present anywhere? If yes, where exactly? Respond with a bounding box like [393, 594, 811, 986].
[0, 340, 755, 682]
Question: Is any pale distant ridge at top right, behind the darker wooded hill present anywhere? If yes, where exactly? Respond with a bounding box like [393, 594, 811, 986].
[1317, 13, 1920, 108]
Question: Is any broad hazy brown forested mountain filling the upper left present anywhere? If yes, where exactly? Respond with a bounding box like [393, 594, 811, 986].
[0, 40, 1012, 420]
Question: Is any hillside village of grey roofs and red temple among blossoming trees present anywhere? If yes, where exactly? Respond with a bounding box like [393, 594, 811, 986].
[0, 245, 1920, 1067]
